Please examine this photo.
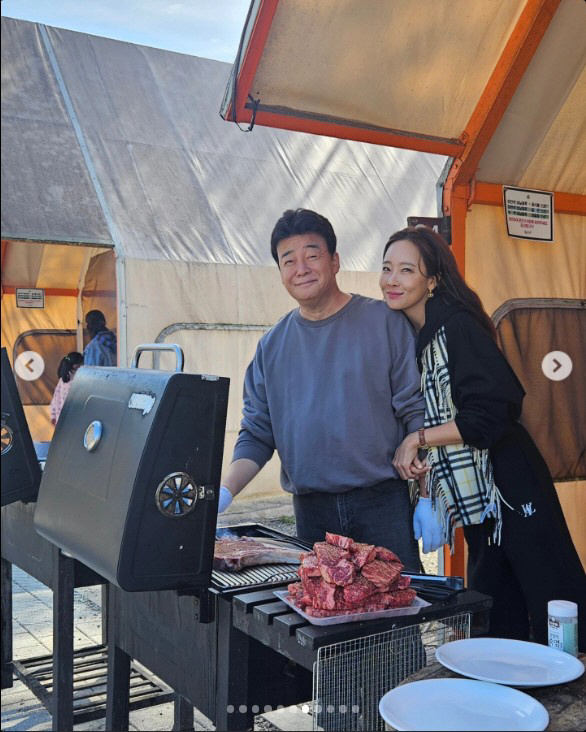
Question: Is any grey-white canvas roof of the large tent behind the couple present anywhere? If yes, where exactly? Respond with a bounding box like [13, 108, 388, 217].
[2, 18, 444, 271]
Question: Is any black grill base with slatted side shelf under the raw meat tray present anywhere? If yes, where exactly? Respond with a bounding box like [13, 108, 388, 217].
[106, 524, 492, 730]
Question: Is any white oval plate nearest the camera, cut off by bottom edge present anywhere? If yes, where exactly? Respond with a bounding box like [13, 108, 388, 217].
[378, 679, 549, 731]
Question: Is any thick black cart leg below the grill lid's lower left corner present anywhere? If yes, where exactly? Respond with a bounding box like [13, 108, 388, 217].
[52, 546, 74, 730]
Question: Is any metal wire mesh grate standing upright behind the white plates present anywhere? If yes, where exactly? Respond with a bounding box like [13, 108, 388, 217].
[313, 613, 470, 730]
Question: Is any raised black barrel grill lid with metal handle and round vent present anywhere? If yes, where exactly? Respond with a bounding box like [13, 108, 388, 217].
[35, 344, 229, 591]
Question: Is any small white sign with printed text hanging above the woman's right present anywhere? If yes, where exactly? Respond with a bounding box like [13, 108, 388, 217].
[503, 186, 553, 241]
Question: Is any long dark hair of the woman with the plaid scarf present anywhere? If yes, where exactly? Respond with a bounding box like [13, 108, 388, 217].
[383, 226, 496, 341]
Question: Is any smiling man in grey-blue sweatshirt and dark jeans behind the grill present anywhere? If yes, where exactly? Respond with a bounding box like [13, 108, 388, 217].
[219, 209, 424, 571]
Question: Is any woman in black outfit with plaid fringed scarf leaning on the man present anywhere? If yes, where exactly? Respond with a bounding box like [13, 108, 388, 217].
[380, 227, 586, 651]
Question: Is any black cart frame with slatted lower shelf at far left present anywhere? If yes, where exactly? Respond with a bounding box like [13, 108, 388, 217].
[1, 501, 173, 730]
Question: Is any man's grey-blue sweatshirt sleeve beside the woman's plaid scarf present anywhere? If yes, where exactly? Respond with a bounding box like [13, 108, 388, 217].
[389, 317, 425, 434]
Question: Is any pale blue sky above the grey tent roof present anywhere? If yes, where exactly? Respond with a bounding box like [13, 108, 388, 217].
[2, 0, 250, 63]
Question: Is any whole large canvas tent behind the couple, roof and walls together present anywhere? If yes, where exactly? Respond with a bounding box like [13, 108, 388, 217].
[2, 18, 446, 498]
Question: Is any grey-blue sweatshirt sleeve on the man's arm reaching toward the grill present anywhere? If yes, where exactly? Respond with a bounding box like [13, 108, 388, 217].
[232, 343, 275, 468]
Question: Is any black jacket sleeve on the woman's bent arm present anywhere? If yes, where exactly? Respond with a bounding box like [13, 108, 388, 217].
[445, 312, 525, 449]
